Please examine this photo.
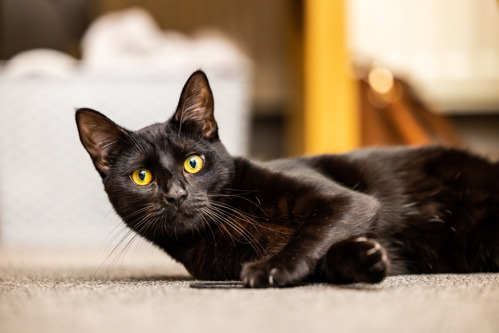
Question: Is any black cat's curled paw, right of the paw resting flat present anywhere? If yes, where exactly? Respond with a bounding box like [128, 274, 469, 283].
[322, 237, 390, 283]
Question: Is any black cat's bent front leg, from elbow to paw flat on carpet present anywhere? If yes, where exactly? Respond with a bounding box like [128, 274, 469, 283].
[241, 188, 379, 288]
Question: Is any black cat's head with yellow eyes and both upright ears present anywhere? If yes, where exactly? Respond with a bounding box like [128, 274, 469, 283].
[76, 71, 234, 238]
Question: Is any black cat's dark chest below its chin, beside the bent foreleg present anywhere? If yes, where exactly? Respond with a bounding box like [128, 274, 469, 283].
[163, 211, 292, 280]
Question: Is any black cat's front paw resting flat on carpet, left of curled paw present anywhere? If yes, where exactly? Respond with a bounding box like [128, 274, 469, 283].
[241, 260, 308, 288]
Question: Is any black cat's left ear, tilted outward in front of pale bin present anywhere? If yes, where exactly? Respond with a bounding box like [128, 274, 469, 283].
[76, 109, 128, 177]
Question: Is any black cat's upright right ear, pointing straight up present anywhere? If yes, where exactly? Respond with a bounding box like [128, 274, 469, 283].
[173, 70, 218, 139]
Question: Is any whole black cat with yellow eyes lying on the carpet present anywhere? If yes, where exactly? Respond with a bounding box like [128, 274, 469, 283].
[76, 71, 499, 287]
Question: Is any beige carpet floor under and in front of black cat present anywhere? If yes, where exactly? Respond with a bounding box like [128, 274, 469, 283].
[0, 250, 499, 333]
